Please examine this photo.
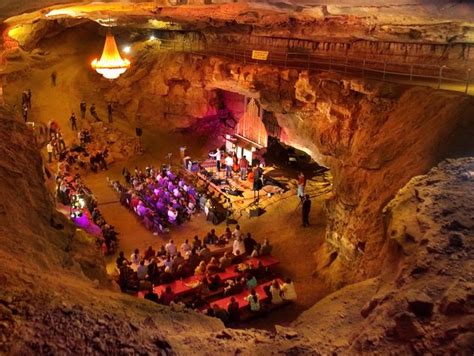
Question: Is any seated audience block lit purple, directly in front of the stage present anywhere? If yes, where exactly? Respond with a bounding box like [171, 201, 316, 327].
[111, 166, 197, 233]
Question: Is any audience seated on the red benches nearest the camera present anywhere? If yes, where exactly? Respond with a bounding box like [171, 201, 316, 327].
[116, 225, 296, 323]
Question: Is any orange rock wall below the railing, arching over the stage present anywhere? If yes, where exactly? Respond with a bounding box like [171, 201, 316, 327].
[98, 49, 474, 288]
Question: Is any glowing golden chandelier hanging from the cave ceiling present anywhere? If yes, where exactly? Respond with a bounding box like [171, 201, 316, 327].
[91, 31, 130, 79]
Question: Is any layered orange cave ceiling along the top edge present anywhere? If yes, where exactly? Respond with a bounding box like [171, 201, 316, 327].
[0, 0, 474, 43]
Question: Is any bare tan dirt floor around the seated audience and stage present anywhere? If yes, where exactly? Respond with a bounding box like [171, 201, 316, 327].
[5, 35, 325, 328]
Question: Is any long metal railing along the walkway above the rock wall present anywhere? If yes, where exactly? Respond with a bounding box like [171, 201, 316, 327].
[154, 38, 474, 94]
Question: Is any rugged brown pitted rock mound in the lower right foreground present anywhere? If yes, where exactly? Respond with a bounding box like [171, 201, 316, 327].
[293, 158, 474, 355]
